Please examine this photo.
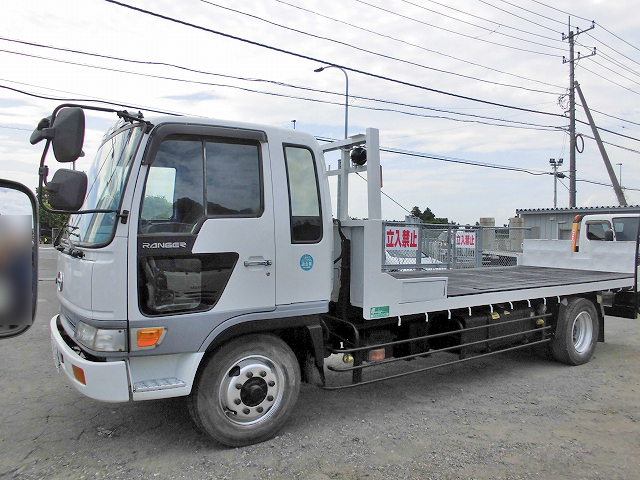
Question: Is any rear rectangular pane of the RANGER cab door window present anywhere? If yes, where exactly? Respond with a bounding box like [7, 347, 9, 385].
[205, 141, 263, 217]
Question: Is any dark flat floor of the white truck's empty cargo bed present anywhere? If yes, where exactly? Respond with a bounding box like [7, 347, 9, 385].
[389, 265, 634, 297]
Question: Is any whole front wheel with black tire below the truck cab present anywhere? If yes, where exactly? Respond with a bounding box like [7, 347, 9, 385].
[189, 335, 300, 447]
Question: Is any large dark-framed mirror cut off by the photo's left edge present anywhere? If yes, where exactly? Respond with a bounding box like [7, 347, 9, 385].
[0, 179, 38, 339]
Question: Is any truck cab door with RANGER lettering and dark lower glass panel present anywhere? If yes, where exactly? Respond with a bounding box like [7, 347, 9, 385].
[129, 125, 275, 334]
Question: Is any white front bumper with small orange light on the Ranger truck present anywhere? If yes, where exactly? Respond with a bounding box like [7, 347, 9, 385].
[49, 315, 131, 402]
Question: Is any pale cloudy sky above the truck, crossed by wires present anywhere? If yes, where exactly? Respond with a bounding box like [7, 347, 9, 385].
[0, 0, 640, 225]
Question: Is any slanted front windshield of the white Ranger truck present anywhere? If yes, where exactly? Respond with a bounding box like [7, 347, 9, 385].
[69, 121, 143, 246]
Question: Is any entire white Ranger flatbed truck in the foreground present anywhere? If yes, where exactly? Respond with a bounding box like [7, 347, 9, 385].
[15, 105, 638, 446]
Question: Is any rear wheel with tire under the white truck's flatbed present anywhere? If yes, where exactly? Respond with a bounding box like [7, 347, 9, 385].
[550, 298, 600, 365]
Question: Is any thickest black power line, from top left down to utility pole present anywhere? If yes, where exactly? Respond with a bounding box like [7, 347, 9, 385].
[104, 0, 564, 118]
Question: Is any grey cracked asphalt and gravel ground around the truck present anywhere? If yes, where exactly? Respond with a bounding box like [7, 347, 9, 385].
[0, 249, 640, 480]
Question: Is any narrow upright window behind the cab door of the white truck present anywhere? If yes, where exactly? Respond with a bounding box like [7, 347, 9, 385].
[284, 146, 322, 243]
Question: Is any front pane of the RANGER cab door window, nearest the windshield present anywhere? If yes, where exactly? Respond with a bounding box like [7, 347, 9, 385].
[140, 135, 204, 233]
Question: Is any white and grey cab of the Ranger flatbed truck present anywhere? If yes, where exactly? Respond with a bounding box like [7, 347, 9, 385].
[42, 108, 333, 442]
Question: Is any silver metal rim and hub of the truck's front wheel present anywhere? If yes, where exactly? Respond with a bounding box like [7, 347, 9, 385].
[220, 356, 283, 424]
